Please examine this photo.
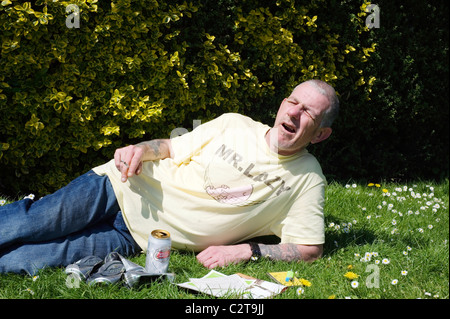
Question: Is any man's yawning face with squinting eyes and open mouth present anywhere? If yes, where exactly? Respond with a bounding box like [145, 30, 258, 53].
[266, 83, 331, 155]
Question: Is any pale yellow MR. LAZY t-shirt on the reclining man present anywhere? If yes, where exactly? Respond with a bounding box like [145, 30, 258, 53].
[94, 113, 326, 251]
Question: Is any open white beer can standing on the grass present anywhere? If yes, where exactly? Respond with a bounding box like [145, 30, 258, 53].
[145, 229, 171, 274]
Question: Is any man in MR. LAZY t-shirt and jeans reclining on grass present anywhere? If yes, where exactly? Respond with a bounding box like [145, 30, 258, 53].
[0, 80, 339, 273]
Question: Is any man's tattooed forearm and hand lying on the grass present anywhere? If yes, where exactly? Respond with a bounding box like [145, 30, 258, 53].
[197, 244, 323, 268]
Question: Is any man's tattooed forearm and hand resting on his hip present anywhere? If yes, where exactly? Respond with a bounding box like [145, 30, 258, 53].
[114, 139, 174, 182]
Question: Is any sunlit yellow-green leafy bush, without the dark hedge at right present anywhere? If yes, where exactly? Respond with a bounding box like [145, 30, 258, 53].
[0, 0, 384, 194]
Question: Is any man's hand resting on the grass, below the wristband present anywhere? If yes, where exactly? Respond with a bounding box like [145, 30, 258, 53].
[197, 244, 252, 269]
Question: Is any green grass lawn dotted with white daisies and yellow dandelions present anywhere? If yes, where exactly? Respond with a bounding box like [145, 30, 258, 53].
[0, 180, 449, 299]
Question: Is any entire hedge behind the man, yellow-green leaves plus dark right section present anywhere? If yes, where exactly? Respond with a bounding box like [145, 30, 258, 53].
[0, 0, 448, 198]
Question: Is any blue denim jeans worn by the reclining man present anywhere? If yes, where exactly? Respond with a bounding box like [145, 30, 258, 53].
[0, 171, 141, 274]
